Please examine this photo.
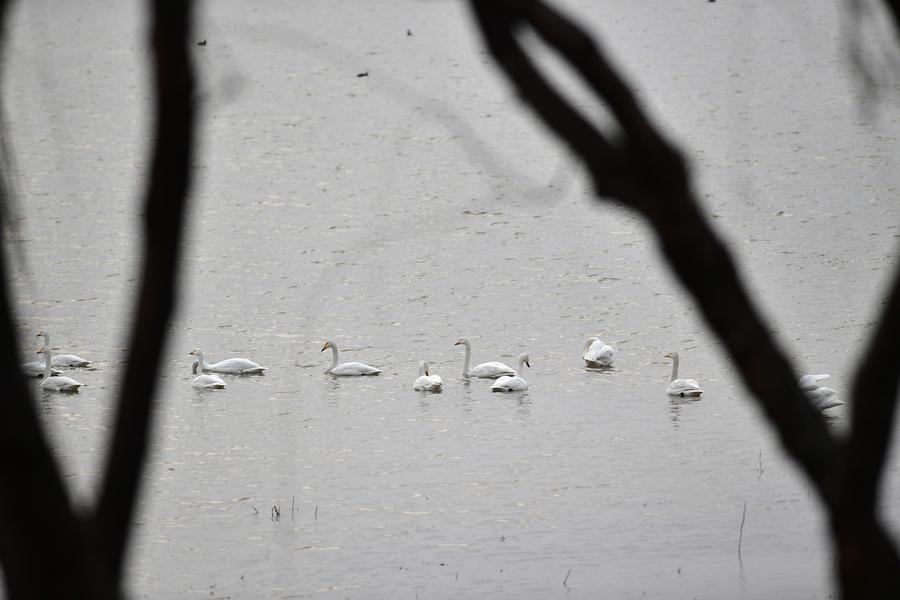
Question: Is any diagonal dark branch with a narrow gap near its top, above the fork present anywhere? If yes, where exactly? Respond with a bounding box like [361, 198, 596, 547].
[472, 1, 838, 502]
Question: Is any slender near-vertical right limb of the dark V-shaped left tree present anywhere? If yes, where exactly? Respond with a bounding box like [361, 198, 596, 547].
[95, 0, 194, 584]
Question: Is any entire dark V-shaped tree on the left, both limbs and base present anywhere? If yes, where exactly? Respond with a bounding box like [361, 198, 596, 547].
[0, 0, 195, 600]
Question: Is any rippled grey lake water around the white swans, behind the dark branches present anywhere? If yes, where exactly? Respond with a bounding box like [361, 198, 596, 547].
[4, 0, 900, 600]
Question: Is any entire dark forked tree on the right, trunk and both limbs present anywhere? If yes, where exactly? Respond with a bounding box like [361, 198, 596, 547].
[471, 0, 900, 598]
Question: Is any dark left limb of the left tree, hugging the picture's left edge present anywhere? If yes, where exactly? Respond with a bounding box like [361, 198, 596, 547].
[0, 0, 112, 599]
